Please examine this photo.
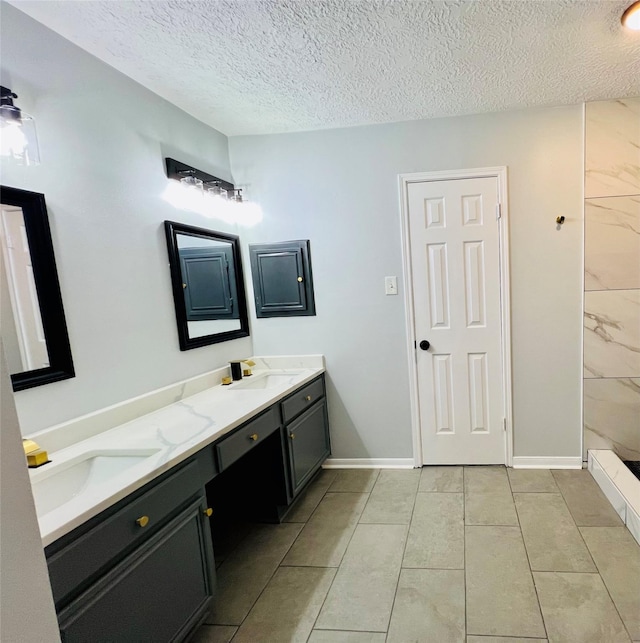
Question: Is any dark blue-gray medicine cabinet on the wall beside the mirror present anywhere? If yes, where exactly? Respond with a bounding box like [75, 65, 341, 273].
[249, 240, 316, 317]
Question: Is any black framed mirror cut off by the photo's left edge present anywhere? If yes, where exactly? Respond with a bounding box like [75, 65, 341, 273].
[0, 186, 75, 391]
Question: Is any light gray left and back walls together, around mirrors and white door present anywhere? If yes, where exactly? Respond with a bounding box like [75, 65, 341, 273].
[0, 4, 582, 458]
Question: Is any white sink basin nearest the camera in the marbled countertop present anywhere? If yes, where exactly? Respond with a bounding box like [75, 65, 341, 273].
[31, 449, 159, 516]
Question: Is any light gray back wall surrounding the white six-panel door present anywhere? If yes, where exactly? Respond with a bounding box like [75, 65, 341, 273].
[229, 106, 582, 458]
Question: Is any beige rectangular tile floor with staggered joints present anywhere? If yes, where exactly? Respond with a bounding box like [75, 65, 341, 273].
[194, 467, 640, 643]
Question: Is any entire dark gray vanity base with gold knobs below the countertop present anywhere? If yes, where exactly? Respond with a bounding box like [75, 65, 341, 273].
[45, 375, 330, 643]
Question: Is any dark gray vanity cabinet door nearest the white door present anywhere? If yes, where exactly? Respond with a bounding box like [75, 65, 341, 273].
[287, 399, 330, 496]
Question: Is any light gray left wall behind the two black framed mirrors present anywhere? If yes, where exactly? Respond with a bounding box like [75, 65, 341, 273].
[0, 3, 252, 434]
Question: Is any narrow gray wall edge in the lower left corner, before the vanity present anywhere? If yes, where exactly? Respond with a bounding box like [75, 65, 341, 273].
[0, 340, 60, 643]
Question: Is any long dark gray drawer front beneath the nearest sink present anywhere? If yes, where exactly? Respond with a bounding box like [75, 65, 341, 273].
[47, 461, 202, 607]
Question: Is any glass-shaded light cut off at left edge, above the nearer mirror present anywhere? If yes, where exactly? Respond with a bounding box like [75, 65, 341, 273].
[0, 86, 40, 165]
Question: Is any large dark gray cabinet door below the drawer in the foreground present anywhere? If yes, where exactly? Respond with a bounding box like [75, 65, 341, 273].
[59, 499, 215, 643]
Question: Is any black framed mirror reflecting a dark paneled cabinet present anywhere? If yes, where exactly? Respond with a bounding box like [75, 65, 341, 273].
[164, 221, 249, 351]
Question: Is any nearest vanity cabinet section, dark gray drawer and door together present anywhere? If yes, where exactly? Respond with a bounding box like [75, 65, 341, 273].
[46, 460, 215, 643]
